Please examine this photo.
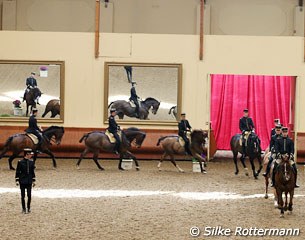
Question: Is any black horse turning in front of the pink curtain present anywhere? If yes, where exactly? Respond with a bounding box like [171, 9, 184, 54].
[230, 132, 263, 179]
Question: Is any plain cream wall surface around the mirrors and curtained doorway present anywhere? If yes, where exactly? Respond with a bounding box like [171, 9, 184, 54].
[0, 31, 305, 161]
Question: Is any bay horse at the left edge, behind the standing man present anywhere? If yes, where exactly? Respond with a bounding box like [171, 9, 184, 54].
[0, 126, 65, 170]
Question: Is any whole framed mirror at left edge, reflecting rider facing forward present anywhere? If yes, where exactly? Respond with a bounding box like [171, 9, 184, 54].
[0, 60, 64, 122]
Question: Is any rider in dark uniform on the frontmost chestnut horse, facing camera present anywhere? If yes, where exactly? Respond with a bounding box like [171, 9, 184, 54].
[272, 127, 299, 188]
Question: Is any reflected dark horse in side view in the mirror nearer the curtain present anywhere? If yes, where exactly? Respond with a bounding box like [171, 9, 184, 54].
[108, 97, 160, 119]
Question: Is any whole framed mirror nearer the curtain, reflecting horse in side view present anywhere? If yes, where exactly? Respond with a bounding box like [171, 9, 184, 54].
[104, 62, 182, 125]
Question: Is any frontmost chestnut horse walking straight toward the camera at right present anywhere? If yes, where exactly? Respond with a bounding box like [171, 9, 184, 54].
[275, 155, 295, 217]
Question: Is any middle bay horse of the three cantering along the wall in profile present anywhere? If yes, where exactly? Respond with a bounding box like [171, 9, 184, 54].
[76, 127, 146, 171]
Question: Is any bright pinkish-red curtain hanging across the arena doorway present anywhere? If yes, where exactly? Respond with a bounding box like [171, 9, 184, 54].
[211, 74, 295, 150]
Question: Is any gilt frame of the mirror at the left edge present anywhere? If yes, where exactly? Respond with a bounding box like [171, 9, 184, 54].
[0, 60, 65, 123]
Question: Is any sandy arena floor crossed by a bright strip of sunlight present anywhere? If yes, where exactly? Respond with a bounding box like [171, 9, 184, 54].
[0, 158, 305, 240]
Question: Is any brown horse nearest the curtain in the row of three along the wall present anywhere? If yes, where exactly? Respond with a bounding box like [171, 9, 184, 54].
[157, 130, 208, 173]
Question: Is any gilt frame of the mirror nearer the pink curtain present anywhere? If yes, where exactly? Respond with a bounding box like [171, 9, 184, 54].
[104, 62, 182, 126]
